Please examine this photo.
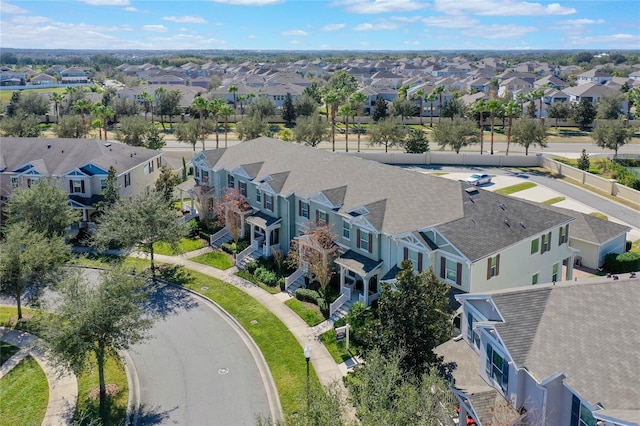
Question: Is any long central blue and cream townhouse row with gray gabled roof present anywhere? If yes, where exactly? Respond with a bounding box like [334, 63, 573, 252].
[192, 137, 576, 310]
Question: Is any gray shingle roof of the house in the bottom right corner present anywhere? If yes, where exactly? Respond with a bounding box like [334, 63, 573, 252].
[492, 278, 640, 419]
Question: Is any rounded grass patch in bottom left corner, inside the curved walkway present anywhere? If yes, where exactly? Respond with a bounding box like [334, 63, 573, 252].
[0, 356, 49, 426]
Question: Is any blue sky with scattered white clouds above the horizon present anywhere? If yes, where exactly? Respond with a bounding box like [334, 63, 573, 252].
[0, 0, 640, 51]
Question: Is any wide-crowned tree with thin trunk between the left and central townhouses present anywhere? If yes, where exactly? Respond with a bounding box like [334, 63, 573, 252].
[93, 191, 186, 277]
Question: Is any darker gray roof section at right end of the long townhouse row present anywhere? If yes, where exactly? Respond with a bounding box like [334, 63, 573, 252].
[438, 187, 573, 261]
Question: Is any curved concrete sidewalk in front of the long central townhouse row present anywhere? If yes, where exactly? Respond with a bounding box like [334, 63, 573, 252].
[131, 252, 350, 386]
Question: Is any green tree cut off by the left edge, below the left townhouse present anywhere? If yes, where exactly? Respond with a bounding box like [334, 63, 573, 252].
[0, 223, 71, 320]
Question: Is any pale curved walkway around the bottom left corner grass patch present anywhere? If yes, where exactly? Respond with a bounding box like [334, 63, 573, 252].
[0, 327, 78, 426]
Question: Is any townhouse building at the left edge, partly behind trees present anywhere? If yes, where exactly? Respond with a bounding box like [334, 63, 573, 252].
[0, 138, 163, 226]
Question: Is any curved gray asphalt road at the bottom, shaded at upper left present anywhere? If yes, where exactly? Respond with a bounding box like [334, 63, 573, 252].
[128, 286, 271, 426]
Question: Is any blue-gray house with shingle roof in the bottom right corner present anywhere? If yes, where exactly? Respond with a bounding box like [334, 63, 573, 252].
[436, 274, 640, 426]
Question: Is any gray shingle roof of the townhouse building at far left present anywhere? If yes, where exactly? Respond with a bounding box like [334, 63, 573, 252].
[0, 138, 161, 176]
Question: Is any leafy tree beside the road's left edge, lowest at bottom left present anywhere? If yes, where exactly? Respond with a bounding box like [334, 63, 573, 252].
[42, 270, 154, 424]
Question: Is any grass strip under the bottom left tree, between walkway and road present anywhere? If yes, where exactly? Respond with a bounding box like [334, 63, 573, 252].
[76, 357, 129, 425]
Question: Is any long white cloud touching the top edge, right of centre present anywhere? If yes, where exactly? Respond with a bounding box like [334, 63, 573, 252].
[434, 0, 576, 16]
